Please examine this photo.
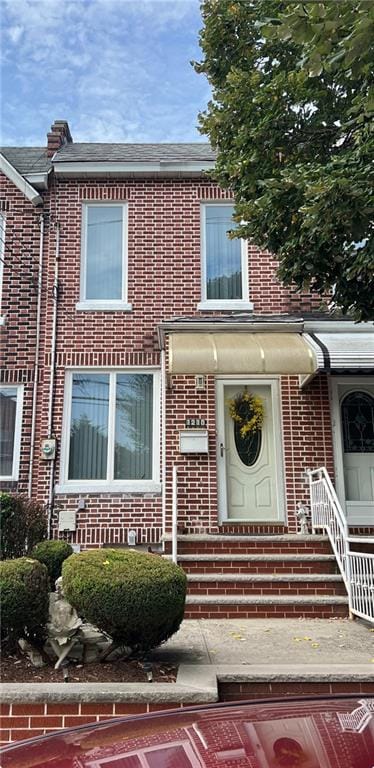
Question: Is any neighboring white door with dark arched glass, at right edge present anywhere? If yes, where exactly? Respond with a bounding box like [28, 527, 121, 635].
[333, 377, 374, 526]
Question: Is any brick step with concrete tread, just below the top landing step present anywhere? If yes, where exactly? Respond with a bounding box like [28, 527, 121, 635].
[165, 553, 338, 574]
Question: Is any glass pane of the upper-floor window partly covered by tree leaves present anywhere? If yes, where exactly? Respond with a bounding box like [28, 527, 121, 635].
[205, 205, 243, 299]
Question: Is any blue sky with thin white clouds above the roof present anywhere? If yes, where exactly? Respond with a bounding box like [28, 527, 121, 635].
[0, 0, 210, 146]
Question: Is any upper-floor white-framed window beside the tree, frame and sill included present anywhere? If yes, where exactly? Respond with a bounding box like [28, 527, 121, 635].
[198, 207, 253, 309]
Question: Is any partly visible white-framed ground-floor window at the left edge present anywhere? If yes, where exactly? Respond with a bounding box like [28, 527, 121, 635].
[0, 384, 23, 480]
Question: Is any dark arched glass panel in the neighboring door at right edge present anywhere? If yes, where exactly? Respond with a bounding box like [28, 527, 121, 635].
[341, 392, 374, 453]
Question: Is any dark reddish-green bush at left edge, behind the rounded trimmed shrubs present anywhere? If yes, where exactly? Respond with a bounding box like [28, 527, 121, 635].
[0, 493, 47, 559]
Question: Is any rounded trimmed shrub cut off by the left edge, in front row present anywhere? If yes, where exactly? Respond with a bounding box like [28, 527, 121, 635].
[0, 557, 49, 649]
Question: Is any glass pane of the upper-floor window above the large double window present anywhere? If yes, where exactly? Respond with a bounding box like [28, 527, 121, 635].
[85, 205, 123, 299]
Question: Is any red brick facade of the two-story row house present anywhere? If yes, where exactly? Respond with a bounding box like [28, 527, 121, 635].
[0, 123, 370, 548]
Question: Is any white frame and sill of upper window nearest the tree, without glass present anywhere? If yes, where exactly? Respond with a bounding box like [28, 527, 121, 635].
[197, 206, 253, 310]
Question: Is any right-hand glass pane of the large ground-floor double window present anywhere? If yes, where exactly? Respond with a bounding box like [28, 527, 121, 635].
[114, 374, 153, 480]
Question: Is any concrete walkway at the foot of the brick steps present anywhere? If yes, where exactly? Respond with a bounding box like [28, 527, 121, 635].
[151, 619, 374, 672]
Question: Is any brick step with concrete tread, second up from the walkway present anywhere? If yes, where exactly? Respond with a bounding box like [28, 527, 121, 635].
[187, 573, 346, 596]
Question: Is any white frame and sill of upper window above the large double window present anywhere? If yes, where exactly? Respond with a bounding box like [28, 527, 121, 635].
[76, 206, 132, 312]
